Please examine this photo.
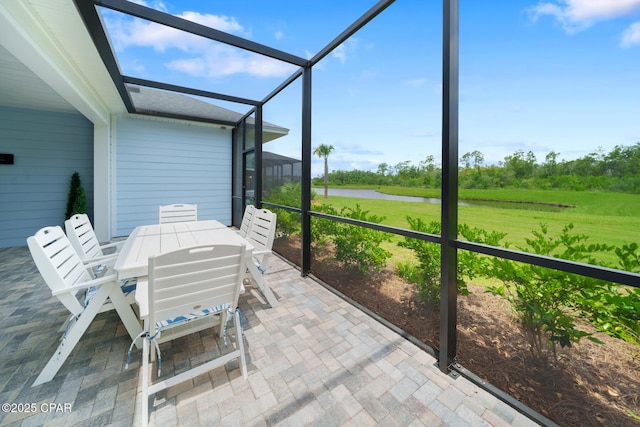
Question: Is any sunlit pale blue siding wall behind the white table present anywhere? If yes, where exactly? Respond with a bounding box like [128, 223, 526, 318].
[112, 116, 231, 236]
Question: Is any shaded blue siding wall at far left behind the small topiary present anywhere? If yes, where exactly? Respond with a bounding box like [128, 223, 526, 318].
[0, 107, 93, 248]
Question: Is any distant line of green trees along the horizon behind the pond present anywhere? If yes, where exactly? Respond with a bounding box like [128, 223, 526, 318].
[314, 142, 640, 193]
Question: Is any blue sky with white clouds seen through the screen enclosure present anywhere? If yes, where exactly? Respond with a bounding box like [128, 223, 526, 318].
[103, 0, 640, 176]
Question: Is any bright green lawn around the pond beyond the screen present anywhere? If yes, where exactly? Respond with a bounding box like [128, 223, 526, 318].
[315, 187, 640, 266]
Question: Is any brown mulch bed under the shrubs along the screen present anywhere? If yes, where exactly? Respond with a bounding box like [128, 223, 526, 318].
[273, 237, 640, 427]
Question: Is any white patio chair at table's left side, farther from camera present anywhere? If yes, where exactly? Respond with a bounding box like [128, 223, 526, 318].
[64, 214, 124, 277]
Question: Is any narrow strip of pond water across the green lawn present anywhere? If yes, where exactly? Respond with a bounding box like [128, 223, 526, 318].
[312, 187, 564, 212]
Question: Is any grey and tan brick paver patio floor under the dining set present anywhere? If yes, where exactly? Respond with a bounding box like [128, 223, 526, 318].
[0, 248, 537, 427]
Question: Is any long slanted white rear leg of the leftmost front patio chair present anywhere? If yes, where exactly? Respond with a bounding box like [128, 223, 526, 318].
[31, 283, 114, 387]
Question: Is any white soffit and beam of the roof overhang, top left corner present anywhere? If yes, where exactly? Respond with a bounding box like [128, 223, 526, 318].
[0, 0, 126, 124]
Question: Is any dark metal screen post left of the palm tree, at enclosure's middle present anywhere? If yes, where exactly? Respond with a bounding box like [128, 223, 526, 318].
[301, 65, 312, 276]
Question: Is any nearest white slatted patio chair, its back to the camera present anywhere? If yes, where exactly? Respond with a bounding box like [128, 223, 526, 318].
[131, 244, 247, 425]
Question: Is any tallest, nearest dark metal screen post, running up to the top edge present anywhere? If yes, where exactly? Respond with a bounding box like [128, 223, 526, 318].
[438, 0, 459, 372]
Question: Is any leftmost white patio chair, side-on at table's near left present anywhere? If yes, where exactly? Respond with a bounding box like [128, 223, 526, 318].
[27, 226, 142, 386]
